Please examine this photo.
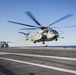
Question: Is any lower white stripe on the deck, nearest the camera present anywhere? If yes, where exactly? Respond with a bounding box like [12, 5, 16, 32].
[0, 57, 76, 74]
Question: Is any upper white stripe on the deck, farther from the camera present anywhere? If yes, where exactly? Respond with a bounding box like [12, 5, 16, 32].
[0, 52, 76, 61]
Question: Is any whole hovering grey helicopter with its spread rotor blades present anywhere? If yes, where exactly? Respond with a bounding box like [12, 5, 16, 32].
[8, 11, 76, 44]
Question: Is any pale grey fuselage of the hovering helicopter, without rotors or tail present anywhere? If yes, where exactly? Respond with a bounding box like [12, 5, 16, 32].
[30, 29, 59, 43]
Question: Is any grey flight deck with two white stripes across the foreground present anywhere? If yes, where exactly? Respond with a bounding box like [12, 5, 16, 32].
[0, 48, 76, 75]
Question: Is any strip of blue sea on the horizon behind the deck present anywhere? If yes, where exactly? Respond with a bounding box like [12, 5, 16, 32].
[26, 45, 76, 49]
